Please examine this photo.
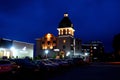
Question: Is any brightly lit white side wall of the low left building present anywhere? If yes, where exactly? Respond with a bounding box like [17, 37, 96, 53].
[12, 40, 34, 58]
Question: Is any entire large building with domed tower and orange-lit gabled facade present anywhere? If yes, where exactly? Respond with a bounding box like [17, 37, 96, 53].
[36, 13, 81, 58]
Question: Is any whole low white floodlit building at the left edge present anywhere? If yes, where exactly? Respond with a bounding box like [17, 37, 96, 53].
[0, 38, 34, 58]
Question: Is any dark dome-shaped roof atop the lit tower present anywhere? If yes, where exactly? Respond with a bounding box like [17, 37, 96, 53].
[58, 16, 73, 28]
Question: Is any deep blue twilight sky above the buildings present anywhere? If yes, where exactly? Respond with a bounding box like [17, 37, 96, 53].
[0, 0, 120, 52]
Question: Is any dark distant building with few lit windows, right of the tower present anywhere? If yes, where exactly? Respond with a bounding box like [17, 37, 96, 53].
[82, 41, 104, 61]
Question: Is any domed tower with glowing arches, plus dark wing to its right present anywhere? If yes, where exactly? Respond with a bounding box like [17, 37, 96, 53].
[57, 13, 81, 57]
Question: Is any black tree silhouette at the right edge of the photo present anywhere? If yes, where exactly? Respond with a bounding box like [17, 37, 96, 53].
[112, 33, 120, 61]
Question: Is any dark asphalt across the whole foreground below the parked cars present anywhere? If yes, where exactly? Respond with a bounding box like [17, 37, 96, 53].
[3, 63, 120, 80]
